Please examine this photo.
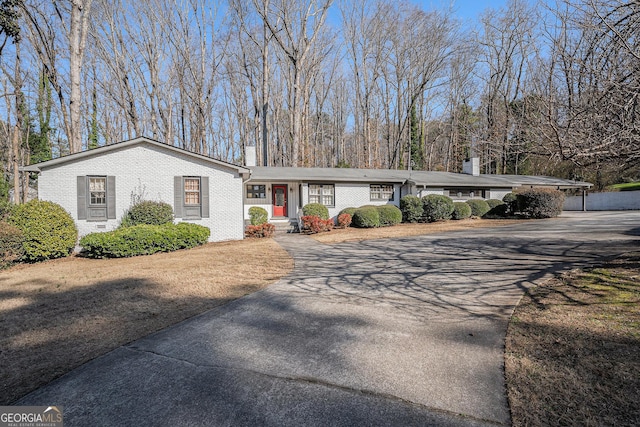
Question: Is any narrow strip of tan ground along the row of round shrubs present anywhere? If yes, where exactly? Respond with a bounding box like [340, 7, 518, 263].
[311, 219, 522, 243]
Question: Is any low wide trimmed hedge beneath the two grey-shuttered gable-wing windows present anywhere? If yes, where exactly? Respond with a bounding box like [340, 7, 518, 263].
[80, 222, 211, 258]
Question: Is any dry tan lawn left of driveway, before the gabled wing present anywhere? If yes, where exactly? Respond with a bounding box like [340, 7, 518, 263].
[0, 239, 293, 405]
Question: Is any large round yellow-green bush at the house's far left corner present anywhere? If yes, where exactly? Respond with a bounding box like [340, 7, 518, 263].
[7, 200, 78, 262]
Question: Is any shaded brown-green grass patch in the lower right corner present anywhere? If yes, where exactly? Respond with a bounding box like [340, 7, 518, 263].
[505, 253, 640, 426]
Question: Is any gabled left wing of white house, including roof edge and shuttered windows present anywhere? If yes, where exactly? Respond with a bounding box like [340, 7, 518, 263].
[23, 138, 250, 241]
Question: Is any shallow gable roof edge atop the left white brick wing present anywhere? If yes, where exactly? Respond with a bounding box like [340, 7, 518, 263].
[20, 136, 250, 176]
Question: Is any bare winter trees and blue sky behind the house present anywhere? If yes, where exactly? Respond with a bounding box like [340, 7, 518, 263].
[0, 0, 640, 204]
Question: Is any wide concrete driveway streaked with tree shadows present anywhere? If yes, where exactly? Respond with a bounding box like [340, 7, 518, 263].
[18, 211, 640, 426]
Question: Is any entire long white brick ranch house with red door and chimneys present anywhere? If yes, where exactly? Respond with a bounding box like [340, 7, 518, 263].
[22, 138, 591, 241]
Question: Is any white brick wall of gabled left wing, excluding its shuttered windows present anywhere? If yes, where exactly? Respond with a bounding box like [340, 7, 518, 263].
[38, 144, 244, 242]
